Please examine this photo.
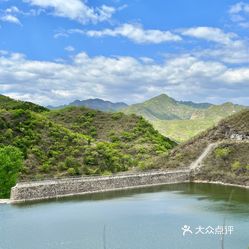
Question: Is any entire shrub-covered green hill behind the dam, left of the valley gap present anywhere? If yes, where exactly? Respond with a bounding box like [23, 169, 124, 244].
[0, 97, 176, 194]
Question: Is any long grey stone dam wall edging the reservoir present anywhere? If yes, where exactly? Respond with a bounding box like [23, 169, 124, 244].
[11, 170, 190, 203]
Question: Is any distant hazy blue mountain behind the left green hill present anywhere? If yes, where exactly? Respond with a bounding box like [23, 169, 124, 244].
[48, 98, 128, 112]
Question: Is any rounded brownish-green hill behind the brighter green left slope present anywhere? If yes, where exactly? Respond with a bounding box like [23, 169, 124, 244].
[46, 107, 176, 163]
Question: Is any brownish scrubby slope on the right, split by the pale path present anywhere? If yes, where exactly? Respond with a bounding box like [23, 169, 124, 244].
[156, 110, 249, 185]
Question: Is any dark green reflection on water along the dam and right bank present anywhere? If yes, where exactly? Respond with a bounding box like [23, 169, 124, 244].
[17, 183, 249, 215]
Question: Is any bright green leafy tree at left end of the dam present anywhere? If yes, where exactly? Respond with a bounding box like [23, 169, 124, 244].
[0, 146, 23, 198]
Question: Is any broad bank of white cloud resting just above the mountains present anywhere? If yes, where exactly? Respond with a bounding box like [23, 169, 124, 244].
[0, 50, 249, 105]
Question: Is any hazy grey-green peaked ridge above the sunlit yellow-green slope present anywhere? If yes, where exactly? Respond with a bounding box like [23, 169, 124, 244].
[122, 94, 246, 120]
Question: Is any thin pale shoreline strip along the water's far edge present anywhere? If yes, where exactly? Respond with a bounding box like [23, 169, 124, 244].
[0, 180, 249, 205]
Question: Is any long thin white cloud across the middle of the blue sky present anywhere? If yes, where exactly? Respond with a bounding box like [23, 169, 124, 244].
[63, 24, 182, 44]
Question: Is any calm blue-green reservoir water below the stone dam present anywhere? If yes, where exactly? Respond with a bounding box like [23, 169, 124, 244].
[0, 183, 249, 249]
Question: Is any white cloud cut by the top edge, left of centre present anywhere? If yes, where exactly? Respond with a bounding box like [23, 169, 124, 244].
[23, 0, 116, 24]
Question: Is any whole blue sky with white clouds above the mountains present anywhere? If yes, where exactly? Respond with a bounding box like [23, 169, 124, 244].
[0, 0, 249, 106]
